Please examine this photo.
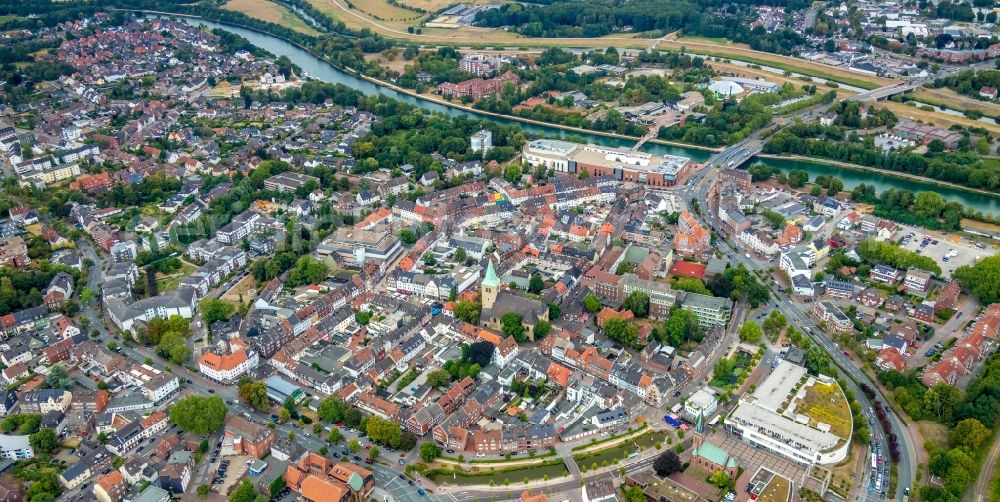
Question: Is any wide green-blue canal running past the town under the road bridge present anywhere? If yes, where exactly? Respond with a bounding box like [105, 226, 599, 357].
[177, 17, 1000, 215]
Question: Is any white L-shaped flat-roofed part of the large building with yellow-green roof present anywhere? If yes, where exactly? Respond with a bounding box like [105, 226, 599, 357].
[725, 361, 850, 464]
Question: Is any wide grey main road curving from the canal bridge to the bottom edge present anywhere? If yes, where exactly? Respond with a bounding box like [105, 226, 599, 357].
[684, 166, 917, 501]
